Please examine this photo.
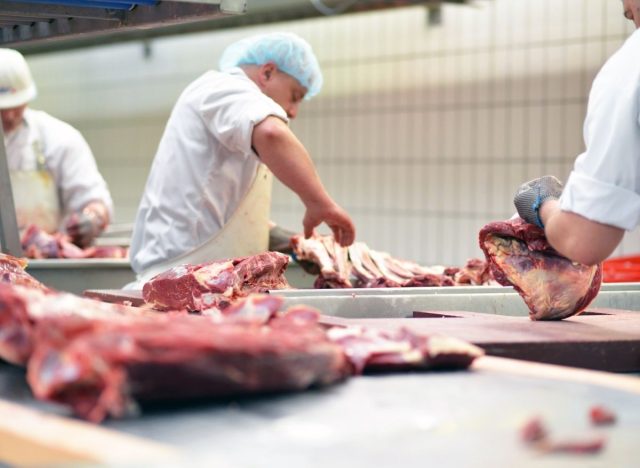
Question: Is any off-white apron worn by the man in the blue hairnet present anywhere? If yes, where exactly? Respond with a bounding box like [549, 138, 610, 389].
[131, 164, 273, 289]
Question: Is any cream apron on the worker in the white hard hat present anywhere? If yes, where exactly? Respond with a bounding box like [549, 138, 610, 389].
[10, 141, 61, 233]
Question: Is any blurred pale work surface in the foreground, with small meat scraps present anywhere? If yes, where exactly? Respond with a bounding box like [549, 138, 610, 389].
[0, 365, 640, 468]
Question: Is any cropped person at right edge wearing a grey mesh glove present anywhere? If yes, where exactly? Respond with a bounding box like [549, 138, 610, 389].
[514, 0, 640, 265]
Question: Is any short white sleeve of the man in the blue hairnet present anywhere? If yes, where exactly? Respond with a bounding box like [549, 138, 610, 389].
[200, 80, 288, 154]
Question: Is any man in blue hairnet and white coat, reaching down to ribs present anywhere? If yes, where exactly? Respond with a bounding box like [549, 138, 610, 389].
[130, 33, 355, 284]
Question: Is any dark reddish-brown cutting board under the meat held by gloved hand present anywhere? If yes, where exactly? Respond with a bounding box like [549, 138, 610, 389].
[322, 308, 640, 372]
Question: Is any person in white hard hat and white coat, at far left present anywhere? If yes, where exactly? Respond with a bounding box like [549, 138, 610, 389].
[0, 49, 113, 247]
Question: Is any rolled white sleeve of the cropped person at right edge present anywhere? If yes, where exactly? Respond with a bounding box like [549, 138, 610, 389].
[560, 49, 640, 230]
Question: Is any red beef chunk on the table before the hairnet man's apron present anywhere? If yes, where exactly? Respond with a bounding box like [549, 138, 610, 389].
[142, 252, 290, 311]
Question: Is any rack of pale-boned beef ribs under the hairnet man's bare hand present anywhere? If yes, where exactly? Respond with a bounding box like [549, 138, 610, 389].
[291, 235, 492, 288]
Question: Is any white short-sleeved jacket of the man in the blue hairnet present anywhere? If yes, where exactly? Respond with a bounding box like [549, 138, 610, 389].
[130, 68, 288, 273]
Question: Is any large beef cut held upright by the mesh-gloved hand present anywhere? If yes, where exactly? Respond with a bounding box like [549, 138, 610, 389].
[479, 218, 602, 320]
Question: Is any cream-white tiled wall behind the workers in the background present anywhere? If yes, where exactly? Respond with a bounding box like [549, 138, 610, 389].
[23, 0, 640, 265]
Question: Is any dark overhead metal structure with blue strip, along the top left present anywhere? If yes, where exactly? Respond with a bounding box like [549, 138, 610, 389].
[0, 0, 466, 54]
